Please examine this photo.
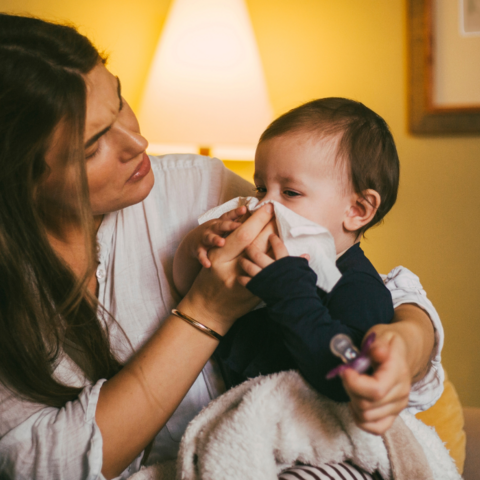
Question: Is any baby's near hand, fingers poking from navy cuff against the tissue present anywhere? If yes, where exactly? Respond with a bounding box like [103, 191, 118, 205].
[238, 233, 310, 287]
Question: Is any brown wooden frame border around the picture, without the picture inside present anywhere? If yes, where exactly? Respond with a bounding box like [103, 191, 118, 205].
[407, 0, 480, 135]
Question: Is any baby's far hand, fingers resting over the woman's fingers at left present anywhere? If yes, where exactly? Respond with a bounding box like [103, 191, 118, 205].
[193, 206, 247, 268]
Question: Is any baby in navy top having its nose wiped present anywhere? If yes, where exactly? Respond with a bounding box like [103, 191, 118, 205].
[174, 98, 399, 401]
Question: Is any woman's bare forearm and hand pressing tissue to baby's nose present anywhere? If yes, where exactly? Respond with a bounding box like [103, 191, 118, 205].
[99, 204, 273, 478]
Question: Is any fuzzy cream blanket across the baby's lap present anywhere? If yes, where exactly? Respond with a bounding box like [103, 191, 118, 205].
[131, 371, 461, 480]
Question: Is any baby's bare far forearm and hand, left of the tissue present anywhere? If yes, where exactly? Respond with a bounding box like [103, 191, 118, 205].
[173, 206, 247, 296]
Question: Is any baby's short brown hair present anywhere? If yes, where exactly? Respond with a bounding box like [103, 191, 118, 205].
[260, 97, 400, 236]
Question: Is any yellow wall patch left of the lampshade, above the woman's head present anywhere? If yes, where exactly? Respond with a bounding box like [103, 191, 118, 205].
[0, 0, 170, 109]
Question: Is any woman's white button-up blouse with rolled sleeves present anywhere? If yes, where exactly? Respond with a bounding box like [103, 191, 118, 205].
[0, 155, 444, 480]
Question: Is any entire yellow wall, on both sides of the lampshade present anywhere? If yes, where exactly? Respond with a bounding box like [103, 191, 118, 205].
[0, 0, 480, 406]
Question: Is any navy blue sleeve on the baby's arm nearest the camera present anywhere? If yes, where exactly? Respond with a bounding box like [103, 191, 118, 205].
[247, 257, 393, 401]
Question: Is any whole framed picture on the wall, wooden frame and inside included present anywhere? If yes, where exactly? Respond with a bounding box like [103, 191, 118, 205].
[408, 0, 480, 135]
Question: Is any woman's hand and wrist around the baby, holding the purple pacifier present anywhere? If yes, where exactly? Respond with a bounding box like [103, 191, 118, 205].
[341, 305, 434, 435]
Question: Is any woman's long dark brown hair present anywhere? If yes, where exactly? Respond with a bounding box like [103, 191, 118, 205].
[0, 14, 120, 407]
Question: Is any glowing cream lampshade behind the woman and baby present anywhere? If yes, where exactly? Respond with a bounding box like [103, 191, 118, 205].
[139, 0, 272, 160]
